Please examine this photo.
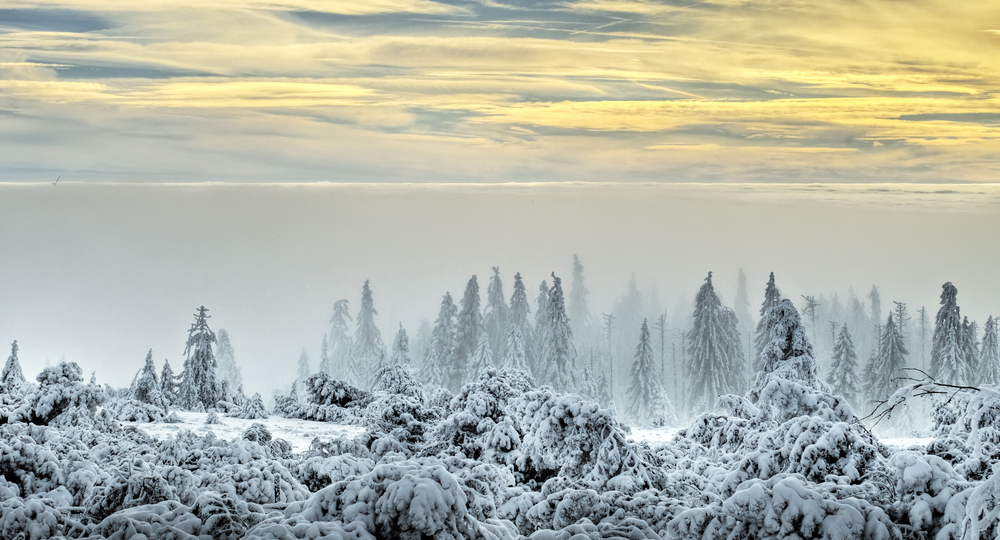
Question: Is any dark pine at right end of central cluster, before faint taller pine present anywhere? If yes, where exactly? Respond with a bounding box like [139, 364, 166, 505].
[542, 273, 578, 392]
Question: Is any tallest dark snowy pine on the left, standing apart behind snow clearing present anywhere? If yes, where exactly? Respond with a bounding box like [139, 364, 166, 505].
[178, 306, 220, 411]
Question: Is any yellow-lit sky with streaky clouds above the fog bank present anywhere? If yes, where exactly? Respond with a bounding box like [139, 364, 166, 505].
[0, 0, 1000, 182]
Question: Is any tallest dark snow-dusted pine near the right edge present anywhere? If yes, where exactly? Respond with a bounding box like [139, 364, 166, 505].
[931, 281, 972, 384]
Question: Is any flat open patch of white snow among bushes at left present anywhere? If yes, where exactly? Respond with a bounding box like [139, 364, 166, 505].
[122, 411, 364, 453]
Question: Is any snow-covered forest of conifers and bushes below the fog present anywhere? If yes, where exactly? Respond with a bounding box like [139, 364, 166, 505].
[0, 255, 1000, 540]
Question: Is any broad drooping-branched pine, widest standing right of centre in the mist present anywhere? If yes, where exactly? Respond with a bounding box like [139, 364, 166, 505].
[686, 272, 742, 410]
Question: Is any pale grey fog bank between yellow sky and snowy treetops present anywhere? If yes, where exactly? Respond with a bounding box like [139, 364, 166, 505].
[0, 182, 1000, 395]
